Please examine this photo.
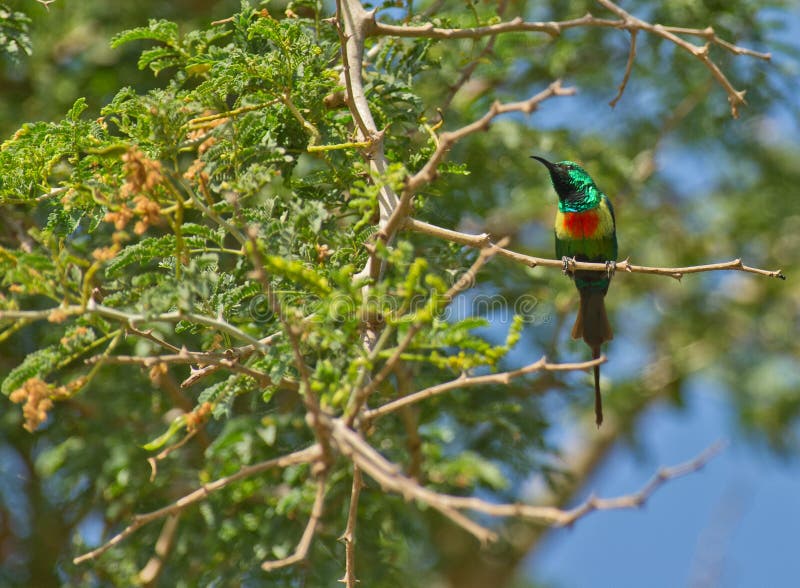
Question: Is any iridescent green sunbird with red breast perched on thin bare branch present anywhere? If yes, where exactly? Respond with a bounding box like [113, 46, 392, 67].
[531, 155, 617, 427]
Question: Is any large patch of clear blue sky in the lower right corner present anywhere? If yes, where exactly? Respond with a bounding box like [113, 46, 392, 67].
[525, 381, 800, 588]
